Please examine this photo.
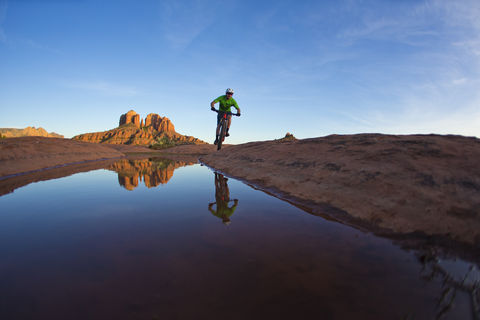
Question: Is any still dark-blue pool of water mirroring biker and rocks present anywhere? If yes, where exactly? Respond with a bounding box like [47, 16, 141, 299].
[0, 158, 480, 319]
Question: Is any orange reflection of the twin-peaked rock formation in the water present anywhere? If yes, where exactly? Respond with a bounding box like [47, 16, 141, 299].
[107, 158, 194, 191]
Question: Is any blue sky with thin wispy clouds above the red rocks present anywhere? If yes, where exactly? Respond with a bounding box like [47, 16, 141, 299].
[0, 0, 480, 143]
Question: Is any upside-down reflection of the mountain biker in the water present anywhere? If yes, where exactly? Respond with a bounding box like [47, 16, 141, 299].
[208, 172, 238, 226]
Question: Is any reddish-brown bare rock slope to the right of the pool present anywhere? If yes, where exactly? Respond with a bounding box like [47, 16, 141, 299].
[200, 134, 480, 246]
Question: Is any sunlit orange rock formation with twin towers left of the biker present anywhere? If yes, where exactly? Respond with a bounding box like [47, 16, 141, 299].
[72, 110, 207, 146]
